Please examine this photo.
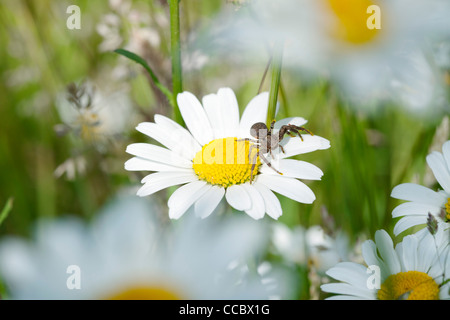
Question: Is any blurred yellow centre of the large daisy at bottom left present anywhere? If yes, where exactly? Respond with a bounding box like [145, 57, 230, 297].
[107, 286, 182, 300]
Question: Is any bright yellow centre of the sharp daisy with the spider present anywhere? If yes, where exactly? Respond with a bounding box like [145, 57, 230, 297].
[193, 138, 261, 188]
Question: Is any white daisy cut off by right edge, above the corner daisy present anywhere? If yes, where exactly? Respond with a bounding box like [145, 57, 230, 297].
[391, 141, 450, 235]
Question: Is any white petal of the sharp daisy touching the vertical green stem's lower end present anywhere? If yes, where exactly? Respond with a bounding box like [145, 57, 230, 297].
[177, 91, 214, 146]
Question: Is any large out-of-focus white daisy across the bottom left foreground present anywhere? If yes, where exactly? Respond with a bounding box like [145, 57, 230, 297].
[0, 197, 282, 300]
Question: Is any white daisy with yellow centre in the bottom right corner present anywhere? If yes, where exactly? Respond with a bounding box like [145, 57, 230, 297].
[321, 229, 450, 300]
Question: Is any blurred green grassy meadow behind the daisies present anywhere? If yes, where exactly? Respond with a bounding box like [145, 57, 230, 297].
[0, 0, 449, 298]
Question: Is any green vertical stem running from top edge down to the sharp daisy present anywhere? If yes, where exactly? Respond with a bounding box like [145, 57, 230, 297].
[169, 0, 183, 125]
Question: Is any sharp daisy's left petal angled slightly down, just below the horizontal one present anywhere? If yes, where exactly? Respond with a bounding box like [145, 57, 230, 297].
[137, 172, 198, 197]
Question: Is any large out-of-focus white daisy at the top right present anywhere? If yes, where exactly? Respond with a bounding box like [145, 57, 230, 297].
[213, 0, 450, 110]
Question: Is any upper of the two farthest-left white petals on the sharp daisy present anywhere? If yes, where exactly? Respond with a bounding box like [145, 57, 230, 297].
[126, 143, 192, 168]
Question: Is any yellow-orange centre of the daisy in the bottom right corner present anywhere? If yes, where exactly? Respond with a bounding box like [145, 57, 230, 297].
[378, 271, 439, 300]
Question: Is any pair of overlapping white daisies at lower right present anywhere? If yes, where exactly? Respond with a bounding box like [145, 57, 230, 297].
[321, 141, 450, 300]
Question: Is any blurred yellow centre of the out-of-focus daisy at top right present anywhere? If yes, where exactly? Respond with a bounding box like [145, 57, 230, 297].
[326, 0, 380, 45]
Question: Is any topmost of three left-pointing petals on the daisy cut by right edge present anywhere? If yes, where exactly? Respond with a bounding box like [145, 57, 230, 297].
[391, 183, 447, 207]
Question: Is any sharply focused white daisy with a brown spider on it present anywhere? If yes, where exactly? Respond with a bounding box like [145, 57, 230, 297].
[125, 88, 330, 219]
